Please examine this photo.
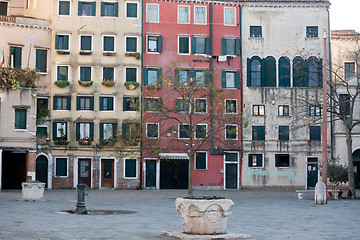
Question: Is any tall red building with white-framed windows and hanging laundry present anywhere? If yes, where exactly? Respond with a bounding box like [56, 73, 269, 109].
[142, 0, 242, 189]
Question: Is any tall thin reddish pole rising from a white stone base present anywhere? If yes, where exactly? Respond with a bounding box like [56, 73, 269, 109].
[321, 28, 327, 186]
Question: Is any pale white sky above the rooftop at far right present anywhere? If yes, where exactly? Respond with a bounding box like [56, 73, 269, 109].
[330, 0, 360, 32]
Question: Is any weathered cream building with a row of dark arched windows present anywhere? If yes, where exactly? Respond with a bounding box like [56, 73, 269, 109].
[241, 0, 330, 188]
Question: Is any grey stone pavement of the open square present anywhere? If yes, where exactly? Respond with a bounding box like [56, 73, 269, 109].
[0, 190, 360, 240]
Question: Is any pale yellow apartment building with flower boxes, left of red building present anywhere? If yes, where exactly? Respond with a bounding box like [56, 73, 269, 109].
[48, 0, 141, 189]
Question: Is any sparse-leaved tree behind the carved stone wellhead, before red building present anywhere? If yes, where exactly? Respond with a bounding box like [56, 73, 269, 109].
[143, 62, 240, 196]
